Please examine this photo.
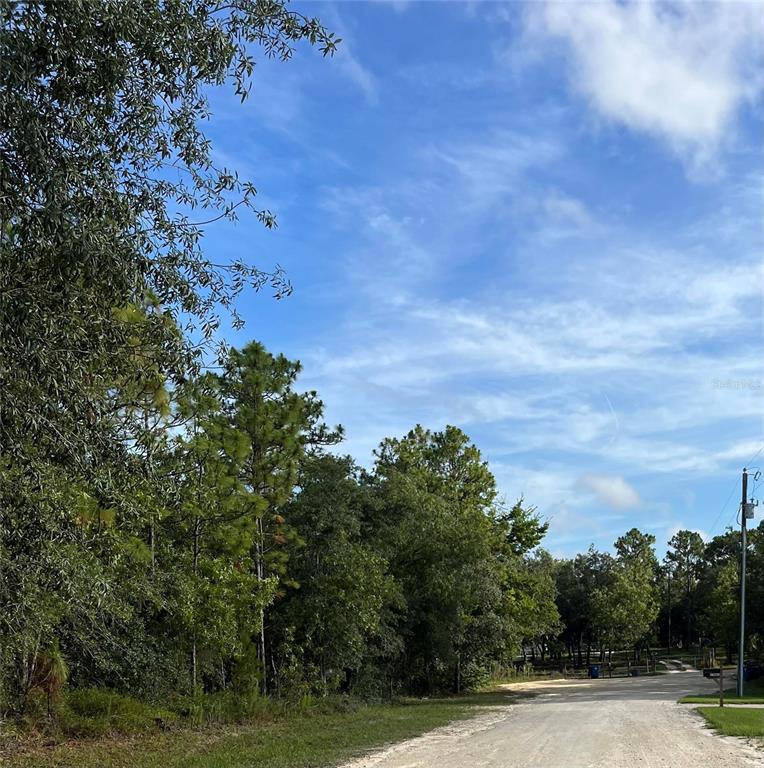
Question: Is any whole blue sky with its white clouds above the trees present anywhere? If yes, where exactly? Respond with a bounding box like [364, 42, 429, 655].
[200, 2, 764, 555]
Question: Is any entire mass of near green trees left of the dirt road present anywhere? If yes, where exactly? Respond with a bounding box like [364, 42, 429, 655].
[0, 0, 568, 733]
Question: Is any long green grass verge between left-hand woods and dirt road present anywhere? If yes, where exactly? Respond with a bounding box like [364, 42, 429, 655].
[0, 691, 516, 768]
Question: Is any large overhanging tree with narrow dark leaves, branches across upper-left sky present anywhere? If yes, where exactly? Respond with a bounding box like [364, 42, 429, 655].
[0, 0, 337, 472]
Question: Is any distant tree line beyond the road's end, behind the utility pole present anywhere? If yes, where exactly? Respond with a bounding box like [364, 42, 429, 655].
[552, 524, 764, 665]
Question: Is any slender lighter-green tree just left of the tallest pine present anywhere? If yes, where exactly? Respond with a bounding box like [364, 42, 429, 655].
[166, 374, 264, 694]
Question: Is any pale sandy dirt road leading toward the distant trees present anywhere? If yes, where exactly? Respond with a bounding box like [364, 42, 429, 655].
[346, 671, 764, 768]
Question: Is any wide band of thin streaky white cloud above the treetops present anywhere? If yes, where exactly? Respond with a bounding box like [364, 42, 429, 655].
[306, 154, 764, 540]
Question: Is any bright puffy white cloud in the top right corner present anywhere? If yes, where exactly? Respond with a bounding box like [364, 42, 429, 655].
[528, 0, 764, 166]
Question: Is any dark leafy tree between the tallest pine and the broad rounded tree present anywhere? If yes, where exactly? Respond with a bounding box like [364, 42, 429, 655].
[271, 454, 401, 694]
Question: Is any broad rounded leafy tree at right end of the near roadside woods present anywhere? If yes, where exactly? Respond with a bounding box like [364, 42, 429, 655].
[365, 426, 554, 690]
